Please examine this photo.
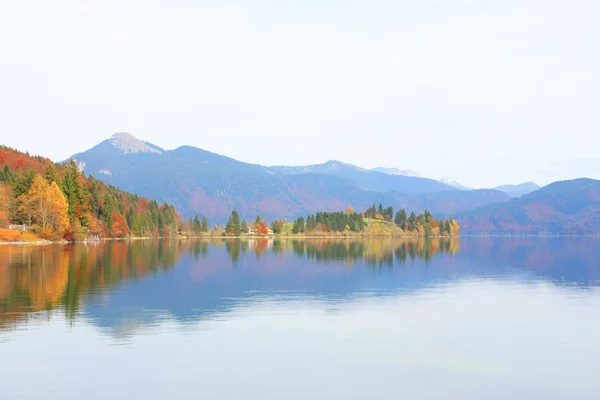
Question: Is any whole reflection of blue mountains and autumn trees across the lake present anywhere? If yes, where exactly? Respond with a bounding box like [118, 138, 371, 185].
[0, 238, 600, 334]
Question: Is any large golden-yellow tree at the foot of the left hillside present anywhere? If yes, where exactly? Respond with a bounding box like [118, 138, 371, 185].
[19, 175, 69, 236]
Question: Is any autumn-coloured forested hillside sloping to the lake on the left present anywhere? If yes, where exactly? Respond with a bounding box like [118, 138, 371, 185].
[0, 147, 179, 240]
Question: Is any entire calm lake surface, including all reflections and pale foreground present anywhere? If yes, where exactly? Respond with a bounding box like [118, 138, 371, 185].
[0, 238, 600, 400]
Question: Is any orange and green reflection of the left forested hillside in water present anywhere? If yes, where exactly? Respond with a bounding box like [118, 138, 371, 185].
[0, 241, 180, 327]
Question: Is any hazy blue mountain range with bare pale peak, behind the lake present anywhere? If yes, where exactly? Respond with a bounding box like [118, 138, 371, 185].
[67, 133, 600, 233]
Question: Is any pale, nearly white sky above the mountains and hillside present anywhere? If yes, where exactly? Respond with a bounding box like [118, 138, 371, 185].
[0, 0, 600, 187]
